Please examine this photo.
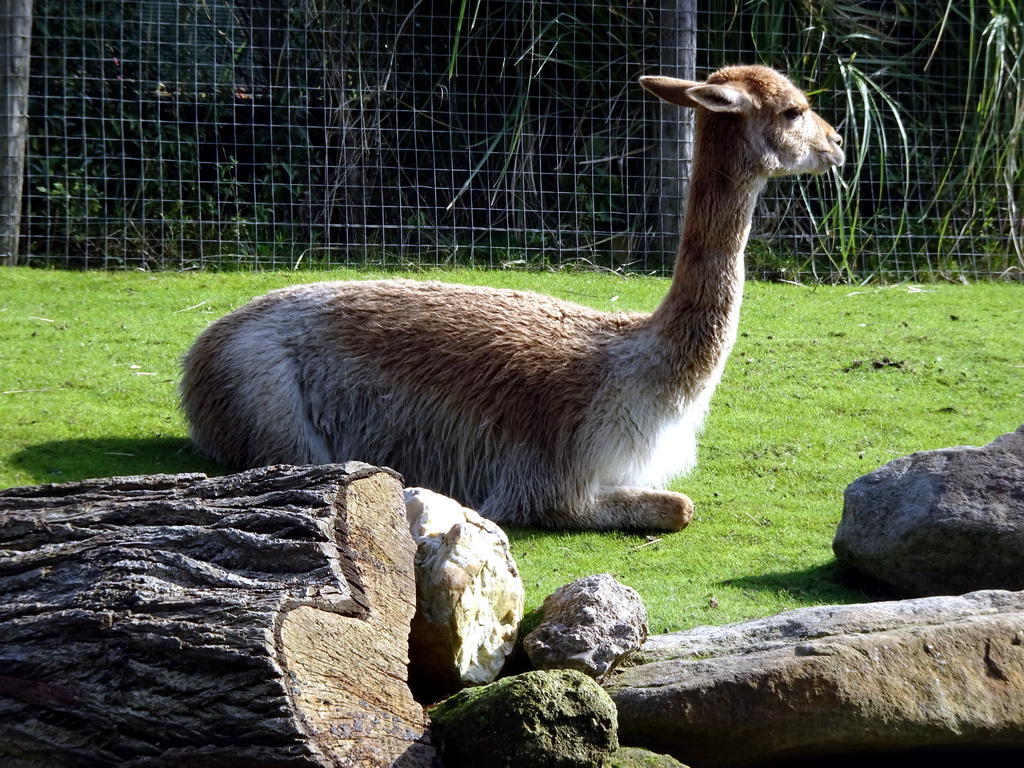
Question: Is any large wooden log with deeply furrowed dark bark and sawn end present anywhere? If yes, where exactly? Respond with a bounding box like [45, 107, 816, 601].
[0, 463, 434, 768]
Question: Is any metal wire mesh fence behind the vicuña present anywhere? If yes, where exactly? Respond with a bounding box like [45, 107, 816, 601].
[20, 0, 1024, 281]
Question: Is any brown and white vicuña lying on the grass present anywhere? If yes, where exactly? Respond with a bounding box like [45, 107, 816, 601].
[181, 67, 843, 530]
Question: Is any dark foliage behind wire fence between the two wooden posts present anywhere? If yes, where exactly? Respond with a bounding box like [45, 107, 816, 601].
[26, 0, 663, 267]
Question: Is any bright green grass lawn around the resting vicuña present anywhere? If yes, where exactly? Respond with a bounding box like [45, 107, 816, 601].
[0, 268, 1024, 632]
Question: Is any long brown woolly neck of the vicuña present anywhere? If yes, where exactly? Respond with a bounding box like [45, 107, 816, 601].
[651, 124, 765, 386]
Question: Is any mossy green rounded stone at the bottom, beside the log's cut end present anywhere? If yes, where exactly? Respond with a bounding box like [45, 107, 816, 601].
[429, 670, 618, 768]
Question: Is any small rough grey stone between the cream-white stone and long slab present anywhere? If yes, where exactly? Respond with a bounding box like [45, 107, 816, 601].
[522, 573, 648, 678]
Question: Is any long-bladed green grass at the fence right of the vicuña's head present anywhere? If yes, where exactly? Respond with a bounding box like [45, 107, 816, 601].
[712, 0, 1024, 281]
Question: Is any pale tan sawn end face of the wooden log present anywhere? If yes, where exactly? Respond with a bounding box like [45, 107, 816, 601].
[278, 474, 433, 766]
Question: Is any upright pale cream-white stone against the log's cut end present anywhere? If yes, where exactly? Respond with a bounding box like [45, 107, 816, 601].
[406, 488, 525, 700]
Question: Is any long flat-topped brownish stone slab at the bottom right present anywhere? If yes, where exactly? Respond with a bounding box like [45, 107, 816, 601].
[605, 590, 1024, 768]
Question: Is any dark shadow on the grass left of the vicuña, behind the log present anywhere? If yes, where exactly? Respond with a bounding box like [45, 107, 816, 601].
[9, 437, 227, 484]
